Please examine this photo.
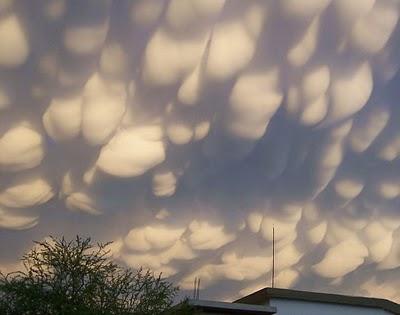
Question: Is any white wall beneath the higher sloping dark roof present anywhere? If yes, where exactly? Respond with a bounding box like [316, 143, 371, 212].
[269, 298, 393, 315]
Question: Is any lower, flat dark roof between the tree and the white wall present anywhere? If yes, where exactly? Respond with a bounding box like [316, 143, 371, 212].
[188, 300, 276, 315]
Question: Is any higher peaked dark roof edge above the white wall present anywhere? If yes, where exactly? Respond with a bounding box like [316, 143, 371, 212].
[234, 288, 400, 314]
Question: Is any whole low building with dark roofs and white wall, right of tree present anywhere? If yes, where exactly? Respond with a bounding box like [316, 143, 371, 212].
[189, 288, 400, 315]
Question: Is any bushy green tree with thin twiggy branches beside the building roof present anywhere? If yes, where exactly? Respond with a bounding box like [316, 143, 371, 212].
[0, 236, 191, 315]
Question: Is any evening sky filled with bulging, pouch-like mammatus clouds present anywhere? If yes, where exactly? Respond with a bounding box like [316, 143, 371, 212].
[0, 0, 400, 302]
